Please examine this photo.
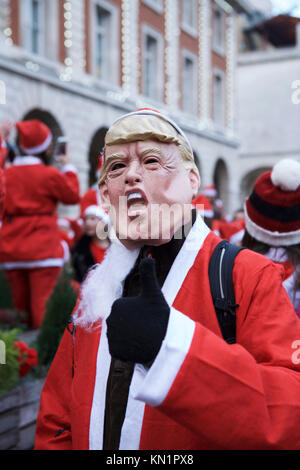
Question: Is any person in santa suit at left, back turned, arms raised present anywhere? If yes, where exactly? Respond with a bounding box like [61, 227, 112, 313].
[0, 120, 79, 328]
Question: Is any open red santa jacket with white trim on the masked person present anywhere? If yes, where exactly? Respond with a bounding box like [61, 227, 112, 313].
[35, 215, 300, 450]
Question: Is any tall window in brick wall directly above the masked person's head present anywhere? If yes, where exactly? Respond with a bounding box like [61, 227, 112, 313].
[143, 27, 163, 101]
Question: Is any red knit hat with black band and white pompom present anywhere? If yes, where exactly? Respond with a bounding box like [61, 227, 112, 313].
[245, 159, 300, 246]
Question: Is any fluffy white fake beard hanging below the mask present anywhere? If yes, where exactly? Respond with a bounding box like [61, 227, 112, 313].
[74, 237, 140, 328]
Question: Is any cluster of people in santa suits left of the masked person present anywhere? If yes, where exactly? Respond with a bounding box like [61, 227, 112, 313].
[0, 120, 109, 329]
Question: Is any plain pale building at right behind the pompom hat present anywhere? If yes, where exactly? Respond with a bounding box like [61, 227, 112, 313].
[237, 11, 300, 199]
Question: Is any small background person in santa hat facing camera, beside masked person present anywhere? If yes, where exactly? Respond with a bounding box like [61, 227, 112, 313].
[71, 205, 111, 283]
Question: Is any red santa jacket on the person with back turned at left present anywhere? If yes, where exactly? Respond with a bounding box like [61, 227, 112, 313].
[0, 156, 79, 269]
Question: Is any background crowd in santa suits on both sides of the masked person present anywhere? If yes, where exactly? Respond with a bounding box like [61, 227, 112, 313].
[0, 115, 300, 328]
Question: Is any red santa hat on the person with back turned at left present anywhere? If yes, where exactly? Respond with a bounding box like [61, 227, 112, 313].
[16, 119, 52, 155]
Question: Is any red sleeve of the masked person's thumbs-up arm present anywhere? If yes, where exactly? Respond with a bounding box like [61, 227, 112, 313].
[136, 263, 300, 450]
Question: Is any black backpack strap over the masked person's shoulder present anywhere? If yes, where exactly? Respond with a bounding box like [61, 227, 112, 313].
[208, 240, 244, 344]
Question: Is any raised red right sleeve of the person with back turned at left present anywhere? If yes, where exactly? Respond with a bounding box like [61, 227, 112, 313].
[48, 165, 80, 204]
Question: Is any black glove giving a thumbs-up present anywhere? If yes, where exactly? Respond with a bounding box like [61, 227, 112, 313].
[106, 258, 170, 364]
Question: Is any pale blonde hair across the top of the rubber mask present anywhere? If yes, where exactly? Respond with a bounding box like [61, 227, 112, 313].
[98, 114, 199, 186]
